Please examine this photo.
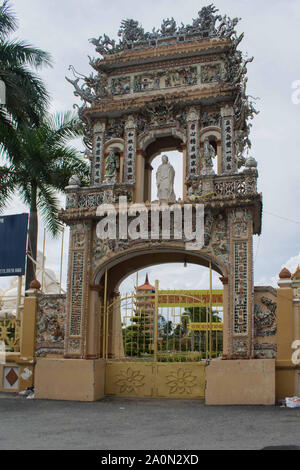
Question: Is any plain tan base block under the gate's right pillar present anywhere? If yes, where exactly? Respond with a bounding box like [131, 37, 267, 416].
[205, 359, 275, 405]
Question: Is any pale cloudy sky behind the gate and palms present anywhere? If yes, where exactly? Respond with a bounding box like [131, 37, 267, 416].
[0, 0, 300, 289]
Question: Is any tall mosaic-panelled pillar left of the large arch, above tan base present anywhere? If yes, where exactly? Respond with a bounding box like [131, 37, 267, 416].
[65, 222, 92, 358]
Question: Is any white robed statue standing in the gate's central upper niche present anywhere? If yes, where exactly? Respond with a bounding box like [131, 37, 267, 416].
[156, 155, 176, 202]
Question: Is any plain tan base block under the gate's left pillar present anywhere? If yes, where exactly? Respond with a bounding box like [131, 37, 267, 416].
[34, 358, 105, 401]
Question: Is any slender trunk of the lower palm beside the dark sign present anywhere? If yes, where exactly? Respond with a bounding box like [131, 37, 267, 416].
[25, 186, 38, 290]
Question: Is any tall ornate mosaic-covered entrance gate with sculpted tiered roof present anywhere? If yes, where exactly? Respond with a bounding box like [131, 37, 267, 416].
[48, 5, 262, 404]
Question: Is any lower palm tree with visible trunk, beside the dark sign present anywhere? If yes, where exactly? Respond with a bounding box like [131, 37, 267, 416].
[0, 112, 89, 289]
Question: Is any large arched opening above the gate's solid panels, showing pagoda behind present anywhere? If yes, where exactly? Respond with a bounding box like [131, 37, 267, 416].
[119, 262, 223, 362]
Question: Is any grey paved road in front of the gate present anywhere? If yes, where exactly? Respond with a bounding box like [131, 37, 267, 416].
[0, 394, 300, 450]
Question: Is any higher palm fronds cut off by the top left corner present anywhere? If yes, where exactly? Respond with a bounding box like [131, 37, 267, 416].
[0, 0, 51, 138]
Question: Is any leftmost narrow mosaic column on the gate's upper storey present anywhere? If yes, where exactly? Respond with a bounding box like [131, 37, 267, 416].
[91, 121, 105, 186]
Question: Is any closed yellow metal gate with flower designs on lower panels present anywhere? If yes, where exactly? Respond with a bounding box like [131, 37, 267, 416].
[102, 281, 223, 398]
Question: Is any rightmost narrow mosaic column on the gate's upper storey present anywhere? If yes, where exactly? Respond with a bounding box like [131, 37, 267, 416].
[221, 106, 237, 173]
